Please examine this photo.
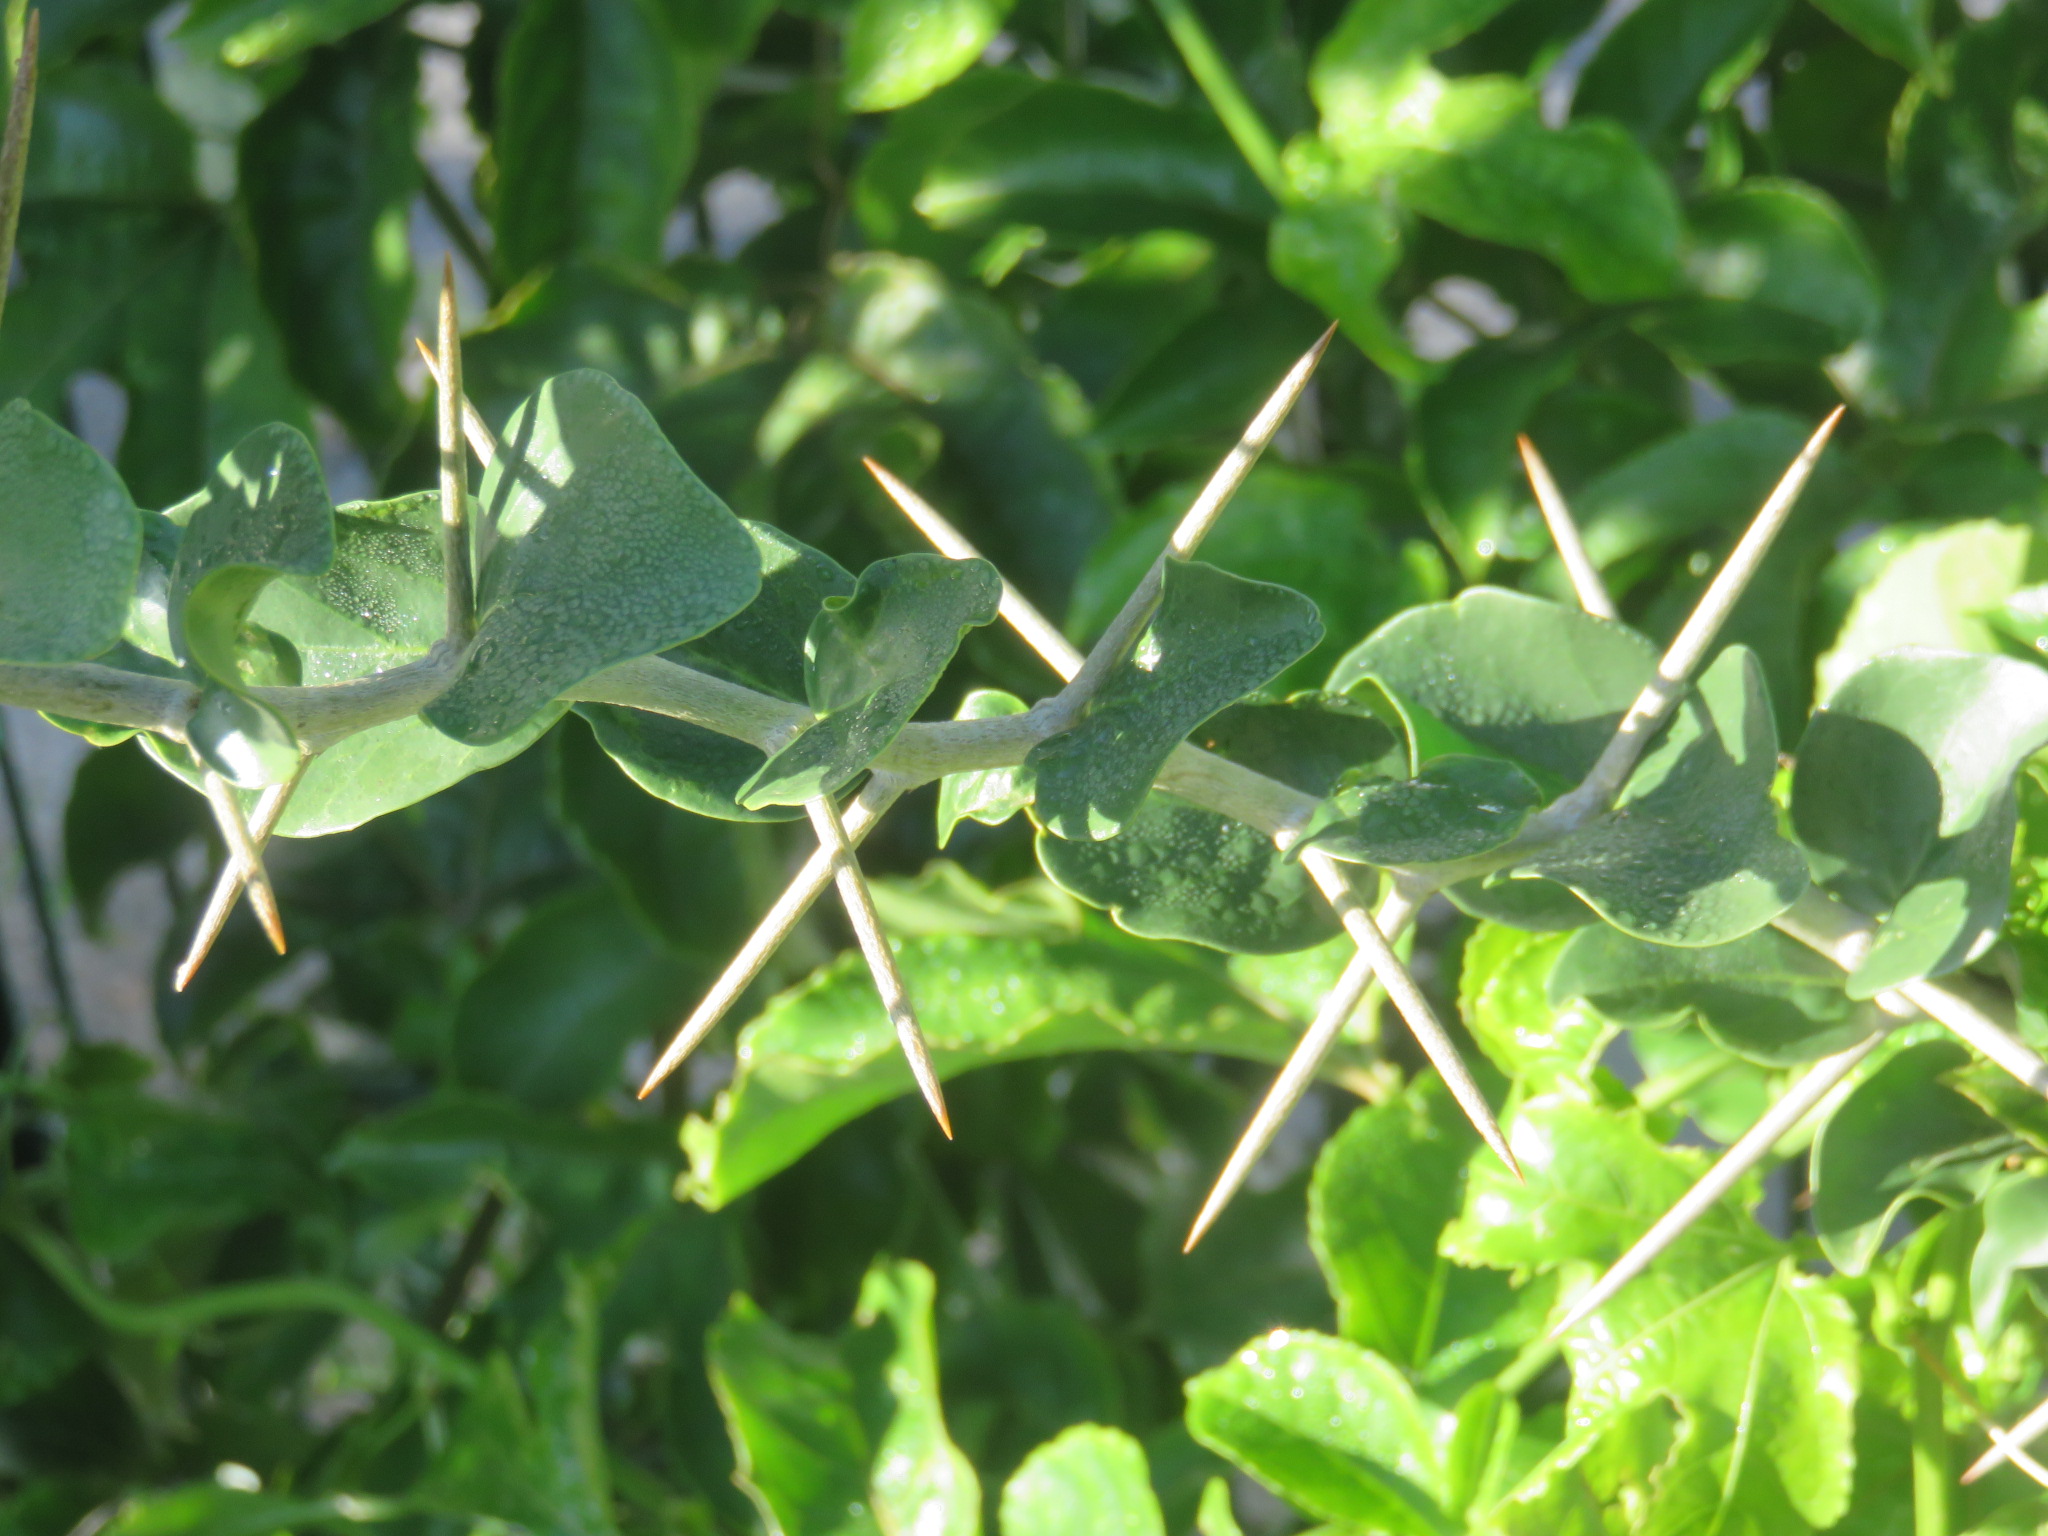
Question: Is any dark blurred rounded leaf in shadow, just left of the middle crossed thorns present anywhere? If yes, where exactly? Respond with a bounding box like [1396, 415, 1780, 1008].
[453, 889, 690, 1108]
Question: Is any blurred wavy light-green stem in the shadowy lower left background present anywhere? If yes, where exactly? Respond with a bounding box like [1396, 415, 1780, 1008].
[6, 1217, 477, 1386]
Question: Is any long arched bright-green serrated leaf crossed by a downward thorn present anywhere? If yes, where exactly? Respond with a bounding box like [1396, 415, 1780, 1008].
[684, 934, 1368, 1210]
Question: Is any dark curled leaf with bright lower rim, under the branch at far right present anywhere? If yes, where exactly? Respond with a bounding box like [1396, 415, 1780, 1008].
[1812, 1038, 2015, 1274]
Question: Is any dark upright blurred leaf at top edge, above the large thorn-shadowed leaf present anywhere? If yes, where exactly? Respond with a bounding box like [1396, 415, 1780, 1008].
[492, 0, 702, 283]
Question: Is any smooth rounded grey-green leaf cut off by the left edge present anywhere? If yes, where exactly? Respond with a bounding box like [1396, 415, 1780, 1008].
[0, 399, 141, 662]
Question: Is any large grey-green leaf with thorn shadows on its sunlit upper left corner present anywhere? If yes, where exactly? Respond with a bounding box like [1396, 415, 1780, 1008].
[422, 369, 760, 745]
